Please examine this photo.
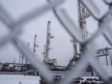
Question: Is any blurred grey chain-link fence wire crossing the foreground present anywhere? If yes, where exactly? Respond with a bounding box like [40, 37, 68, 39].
[0, 0, 112, 84]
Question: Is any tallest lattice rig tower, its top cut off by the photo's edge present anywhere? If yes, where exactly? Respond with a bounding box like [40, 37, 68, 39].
[77, 0, 90, 54]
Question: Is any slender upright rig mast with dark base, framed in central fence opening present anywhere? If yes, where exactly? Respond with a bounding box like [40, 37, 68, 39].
[40, 21, 65, 84]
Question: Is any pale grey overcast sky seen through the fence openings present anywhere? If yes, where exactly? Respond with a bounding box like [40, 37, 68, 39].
[0, 0, 109, 65]
